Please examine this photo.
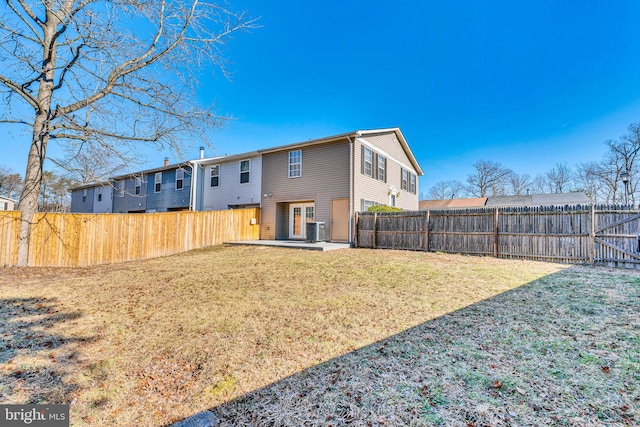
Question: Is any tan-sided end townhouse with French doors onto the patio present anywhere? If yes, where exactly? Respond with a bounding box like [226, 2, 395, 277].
[259, 128, 422, 242]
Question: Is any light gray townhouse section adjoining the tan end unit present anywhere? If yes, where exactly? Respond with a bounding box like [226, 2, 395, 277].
[191, 151, 262, 211]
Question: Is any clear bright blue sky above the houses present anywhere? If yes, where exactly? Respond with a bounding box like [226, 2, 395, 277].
[0, 0, 640, 196]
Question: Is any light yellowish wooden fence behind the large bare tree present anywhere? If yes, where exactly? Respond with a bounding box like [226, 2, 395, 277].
[0, 208, 260, 267]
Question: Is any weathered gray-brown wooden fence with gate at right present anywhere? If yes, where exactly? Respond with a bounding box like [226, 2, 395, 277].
[354, 205, 640, 268]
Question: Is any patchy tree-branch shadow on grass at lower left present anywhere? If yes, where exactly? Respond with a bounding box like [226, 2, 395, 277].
[0, 298, 92, 404]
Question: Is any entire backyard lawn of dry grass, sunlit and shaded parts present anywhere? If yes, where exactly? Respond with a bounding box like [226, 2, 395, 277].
[0, 247, 640, 426]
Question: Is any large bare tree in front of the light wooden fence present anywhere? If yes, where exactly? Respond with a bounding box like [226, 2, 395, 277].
[0, 0, 254, 266]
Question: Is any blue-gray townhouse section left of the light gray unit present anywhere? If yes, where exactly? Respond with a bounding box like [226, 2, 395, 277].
[113, 161, 191, 213]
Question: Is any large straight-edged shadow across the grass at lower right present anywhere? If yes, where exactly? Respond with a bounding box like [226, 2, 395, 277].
[170, 267, 640, 427]
